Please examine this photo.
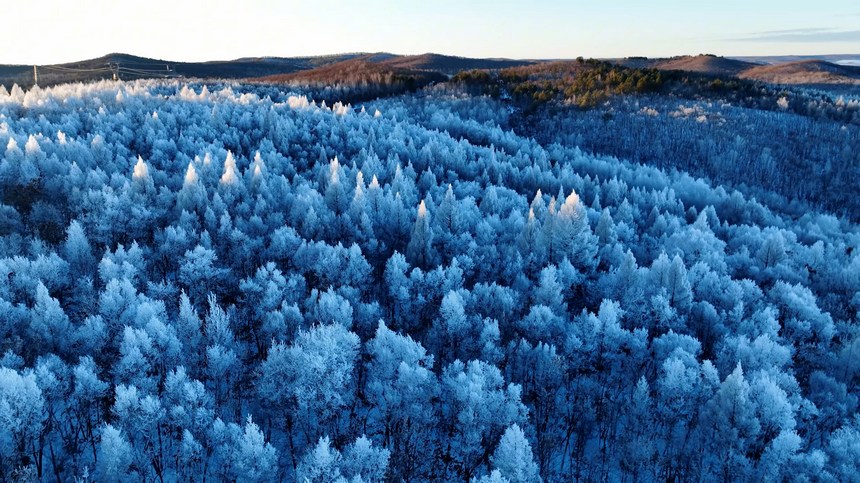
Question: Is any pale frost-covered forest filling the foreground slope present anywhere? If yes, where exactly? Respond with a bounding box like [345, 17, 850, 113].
[0, 81, 860, 483]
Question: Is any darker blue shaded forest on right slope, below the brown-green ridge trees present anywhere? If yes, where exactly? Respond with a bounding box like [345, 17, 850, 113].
[524, 95, 860, 220]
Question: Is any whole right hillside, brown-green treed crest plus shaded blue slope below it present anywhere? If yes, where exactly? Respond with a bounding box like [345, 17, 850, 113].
[450, 59, 860, 216]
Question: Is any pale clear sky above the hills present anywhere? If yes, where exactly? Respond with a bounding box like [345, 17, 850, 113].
[6, 0, 860, 64]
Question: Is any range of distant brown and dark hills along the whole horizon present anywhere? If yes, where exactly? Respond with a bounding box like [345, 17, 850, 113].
[10, 52, 860, 90]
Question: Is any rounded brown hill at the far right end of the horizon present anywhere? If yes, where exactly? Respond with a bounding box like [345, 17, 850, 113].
[739, 60, 860, 85]
